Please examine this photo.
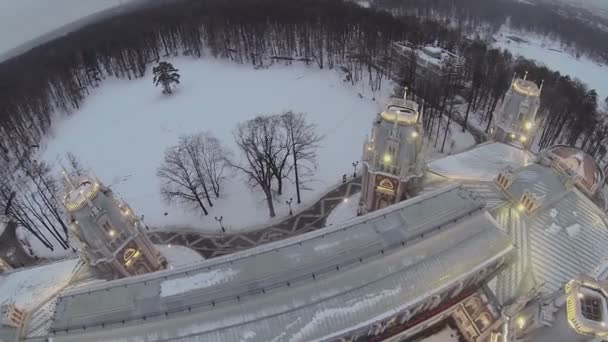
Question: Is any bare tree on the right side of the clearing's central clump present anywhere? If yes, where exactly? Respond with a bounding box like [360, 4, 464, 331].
[281, 111, 323, 203]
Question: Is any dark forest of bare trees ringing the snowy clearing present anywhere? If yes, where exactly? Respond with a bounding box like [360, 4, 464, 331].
[0, 0, 608, 252]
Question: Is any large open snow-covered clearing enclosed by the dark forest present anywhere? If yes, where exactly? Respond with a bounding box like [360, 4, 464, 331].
[43, 57, 392, 233]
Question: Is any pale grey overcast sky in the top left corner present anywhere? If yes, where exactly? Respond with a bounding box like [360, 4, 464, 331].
[0, 0, 126, 55]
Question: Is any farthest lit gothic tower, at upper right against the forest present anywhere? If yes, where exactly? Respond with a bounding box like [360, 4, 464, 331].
[490, 73, 542, 148]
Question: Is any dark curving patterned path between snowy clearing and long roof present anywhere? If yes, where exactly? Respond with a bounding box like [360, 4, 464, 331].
[148, 177, 361, 259]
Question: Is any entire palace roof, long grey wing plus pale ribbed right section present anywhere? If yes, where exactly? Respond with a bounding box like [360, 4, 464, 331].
[9, 142, 608, 342]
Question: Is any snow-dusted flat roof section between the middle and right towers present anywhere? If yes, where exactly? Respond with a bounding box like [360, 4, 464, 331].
[428, 142, 534, 181]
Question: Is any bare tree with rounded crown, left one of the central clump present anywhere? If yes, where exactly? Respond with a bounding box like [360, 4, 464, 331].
[232, 116, 281, 217]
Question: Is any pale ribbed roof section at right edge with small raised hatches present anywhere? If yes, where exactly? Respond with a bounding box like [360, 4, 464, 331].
[493, 188, 608, 302]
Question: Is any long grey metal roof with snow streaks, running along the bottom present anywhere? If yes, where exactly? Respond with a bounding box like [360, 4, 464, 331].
[47, 186, 512, 342]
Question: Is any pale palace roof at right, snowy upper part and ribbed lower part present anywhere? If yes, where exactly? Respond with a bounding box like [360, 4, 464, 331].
[429, 142, 608, 303]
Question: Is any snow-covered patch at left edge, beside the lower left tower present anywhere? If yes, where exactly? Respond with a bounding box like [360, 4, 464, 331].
[0, 259, 78, 310]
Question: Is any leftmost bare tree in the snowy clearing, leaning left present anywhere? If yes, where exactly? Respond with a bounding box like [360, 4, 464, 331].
[156, 146, 209, 215]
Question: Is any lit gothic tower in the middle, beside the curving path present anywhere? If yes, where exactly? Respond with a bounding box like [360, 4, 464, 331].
[359, 94, 425, 214]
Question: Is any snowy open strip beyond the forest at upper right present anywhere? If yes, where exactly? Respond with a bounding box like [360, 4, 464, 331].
[493, 27, 608, 104]
